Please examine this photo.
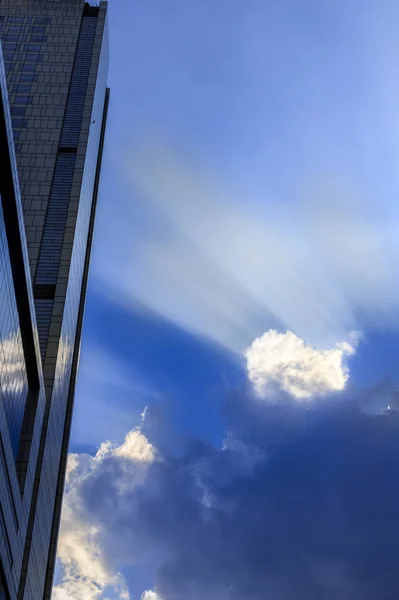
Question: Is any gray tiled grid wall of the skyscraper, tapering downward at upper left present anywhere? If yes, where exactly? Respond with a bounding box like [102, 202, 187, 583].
[0, 0, 84, 278]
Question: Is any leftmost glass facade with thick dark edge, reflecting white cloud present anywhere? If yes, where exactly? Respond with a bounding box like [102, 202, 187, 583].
[0, 41, 45, 600]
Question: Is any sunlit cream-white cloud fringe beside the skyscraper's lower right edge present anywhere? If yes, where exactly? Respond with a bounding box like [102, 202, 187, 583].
[54, 429, 155, 600]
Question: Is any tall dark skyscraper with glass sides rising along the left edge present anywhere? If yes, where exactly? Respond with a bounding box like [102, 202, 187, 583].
[0, 0, 109, 600]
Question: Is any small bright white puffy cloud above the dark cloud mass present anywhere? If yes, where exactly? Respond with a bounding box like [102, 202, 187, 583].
[245, 329, 355, 401]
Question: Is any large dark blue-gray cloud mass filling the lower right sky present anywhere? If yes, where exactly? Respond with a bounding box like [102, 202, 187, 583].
[57, 393, 399, 600]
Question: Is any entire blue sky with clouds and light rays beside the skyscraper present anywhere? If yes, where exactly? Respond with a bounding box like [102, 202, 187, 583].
[54, 0, 399, 600]
